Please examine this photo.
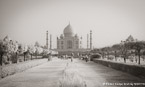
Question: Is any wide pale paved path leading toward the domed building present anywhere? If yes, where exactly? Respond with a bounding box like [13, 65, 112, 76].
[0, 59, 145, 87]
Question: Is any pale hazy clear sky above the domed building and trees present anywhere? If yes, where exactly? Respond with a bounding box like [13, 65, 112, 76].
[0, 0, 145, 48]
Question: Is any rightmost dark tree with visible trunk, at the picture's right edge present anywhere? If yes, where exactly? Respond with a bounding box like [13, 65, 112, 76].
[131, 41, 145, 64]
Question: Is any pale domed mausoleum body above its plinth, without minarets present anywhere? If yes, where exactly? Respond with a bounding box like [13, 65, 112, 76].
[57, 24, 81, 50]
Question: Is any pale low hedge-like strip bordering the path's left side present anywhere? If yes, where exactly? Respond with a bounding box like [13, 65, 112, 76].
[0, 59, 48, 78]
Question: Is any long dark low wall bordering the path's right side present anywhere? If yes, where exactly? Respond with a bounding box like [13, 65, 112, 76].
[94, 59, 145, 78]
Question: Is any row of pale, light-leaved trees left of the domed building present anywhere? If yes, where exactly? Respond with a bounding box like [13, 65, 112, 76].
[0, 36, 49, 65]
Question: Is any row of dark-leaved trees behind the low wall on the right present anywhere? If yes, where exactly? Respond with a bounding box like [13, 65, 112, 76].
[93, 41, 145, 64]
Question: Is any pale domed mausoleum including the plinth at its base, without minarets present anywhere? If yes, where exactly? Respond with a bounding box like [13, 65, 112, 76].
[56, 23, 88, 56]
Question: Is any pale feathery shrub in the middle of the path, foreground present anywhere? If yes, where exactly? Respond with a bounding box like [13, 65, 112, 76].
[59, 64, 87, 87]
